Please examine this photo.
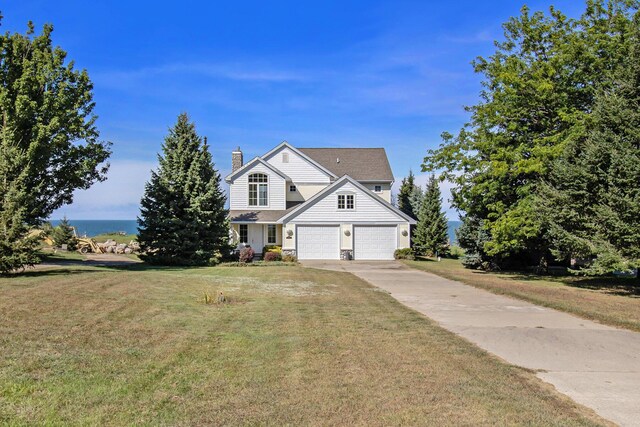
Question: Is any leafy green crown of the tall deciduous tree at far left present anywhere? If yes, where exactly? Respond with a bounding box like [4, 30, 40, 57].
[0, 17, 110, 225]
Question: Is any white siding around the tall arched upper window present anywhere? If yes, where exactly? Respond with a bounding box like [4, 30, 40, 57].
[229, 163, 288, 210]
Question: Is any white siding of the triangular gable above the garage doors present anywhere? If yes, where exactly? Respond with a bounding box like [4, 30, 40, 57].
[290, 181, 407, 224]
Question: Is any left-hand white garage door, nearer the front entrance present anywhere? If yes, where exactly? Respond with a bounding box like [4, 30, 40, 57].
[296, 225, 340, 259]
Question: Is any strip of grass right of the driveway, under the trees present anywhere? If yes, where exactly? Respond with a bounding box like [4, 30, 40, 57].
[405, 259, 640, 331]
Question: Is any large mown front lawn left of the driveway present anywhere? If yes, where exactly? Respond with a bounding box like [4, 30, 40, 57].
[0, 266, 604, 426]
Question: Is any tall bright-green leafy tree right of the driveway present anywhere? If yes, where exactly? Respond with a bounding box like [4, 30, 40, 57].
[423, 0, 637, 265]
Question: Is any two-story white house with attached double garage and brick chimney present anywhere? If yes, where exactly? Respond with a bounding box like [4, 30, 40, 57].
[225, 141, 415, 260]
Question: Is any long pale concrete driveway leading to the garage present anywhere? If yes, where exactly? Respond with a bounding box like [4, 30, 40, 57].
[303, 261, 640, 426]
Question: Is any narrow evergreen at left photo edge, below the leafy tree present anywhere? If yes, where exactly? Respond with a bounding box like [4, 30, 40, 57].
[0, 141, 39, 274]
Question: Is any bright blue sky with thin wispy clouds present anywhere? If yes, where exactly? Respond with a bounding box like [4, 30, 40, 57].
[0, 0, 583, 219]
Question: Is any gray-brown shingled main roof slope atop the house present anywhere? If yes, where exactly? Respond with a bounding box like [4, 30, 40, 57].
[298, 148, 393, 181]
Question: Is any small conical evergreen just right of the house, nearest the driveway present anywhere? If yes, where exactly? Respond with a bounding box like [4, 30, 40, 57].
[413, 175, 449, 255]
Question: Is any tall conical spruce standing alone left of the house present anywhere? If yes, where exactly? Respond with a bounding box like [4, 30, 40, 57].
[138, 113, 229, 265]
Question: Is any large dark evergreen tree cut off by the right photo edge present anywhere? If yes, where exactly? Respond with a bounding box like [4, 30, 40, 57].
[539, 13, 640, 274]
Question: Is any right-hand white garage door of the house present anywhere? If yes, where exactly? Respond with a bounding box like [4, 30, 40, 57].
[353, 225, 398, 259]
